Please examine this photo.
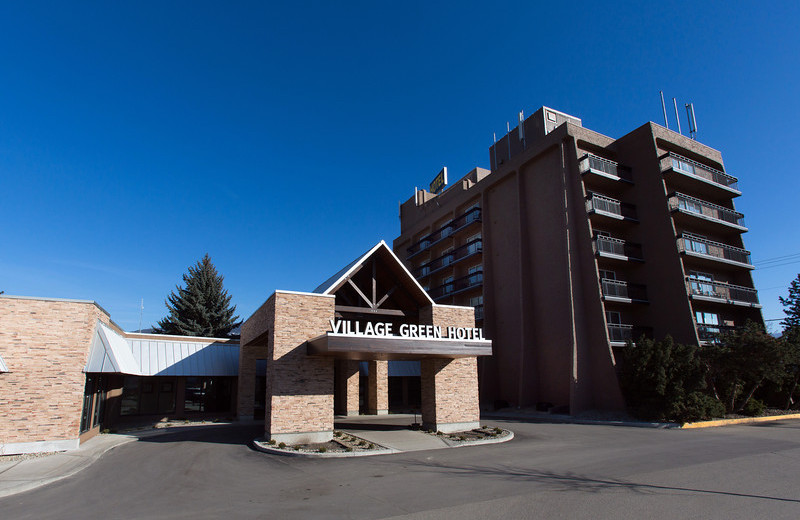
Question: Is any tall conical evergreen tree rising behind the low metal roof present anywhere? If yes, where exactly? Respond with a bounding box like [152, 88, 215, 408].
[155, 254, 239, 338]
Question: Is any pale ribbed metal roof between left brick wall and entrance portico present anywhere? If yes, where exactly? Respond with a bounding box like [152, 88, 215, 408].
[85, 323, 239, 376]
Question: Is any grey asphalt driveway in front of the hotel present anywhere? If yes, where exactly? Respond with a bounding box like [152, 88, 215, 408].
[0, 421, 800, 519]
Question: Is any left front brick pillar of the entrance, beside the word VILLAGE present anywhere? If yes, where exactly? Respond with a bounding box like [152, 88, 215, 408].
[265, 292, 335, 443]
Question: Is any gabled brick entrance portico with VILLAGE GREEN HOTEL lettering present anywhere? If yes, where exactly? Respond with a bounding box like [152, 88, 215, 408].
[238, 242, 492, 444]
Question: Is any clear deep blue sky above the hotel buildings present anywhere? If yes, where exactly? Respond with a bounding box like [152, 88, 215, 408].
[0, 0, 800, 330]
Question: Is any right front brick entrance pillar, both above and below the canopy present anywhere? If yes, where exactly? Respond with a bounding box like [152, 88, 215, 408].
[420, 305, 480, 433]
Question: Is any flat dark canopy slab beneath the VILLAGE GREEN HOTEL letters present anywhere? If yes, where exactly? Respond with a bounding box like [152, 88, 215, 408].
[307, 332, 492, 360]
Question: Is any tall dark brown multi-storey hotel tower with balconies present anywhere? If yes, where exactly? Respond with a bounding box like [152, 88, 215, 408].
[394, 107, 763, 413]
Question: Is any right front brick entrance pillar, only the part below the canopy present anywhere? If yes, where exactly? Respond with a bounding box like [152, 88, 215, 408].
[420, 357, 480, 433]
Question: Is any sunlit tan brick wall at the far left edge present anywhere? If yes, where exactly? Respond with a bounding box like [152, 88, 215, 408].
[0, 297, 111, 454]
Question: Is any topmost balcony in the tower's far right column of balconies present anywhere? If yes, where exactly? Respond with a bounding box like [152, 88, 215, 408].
[661, 153, 742, 197]
